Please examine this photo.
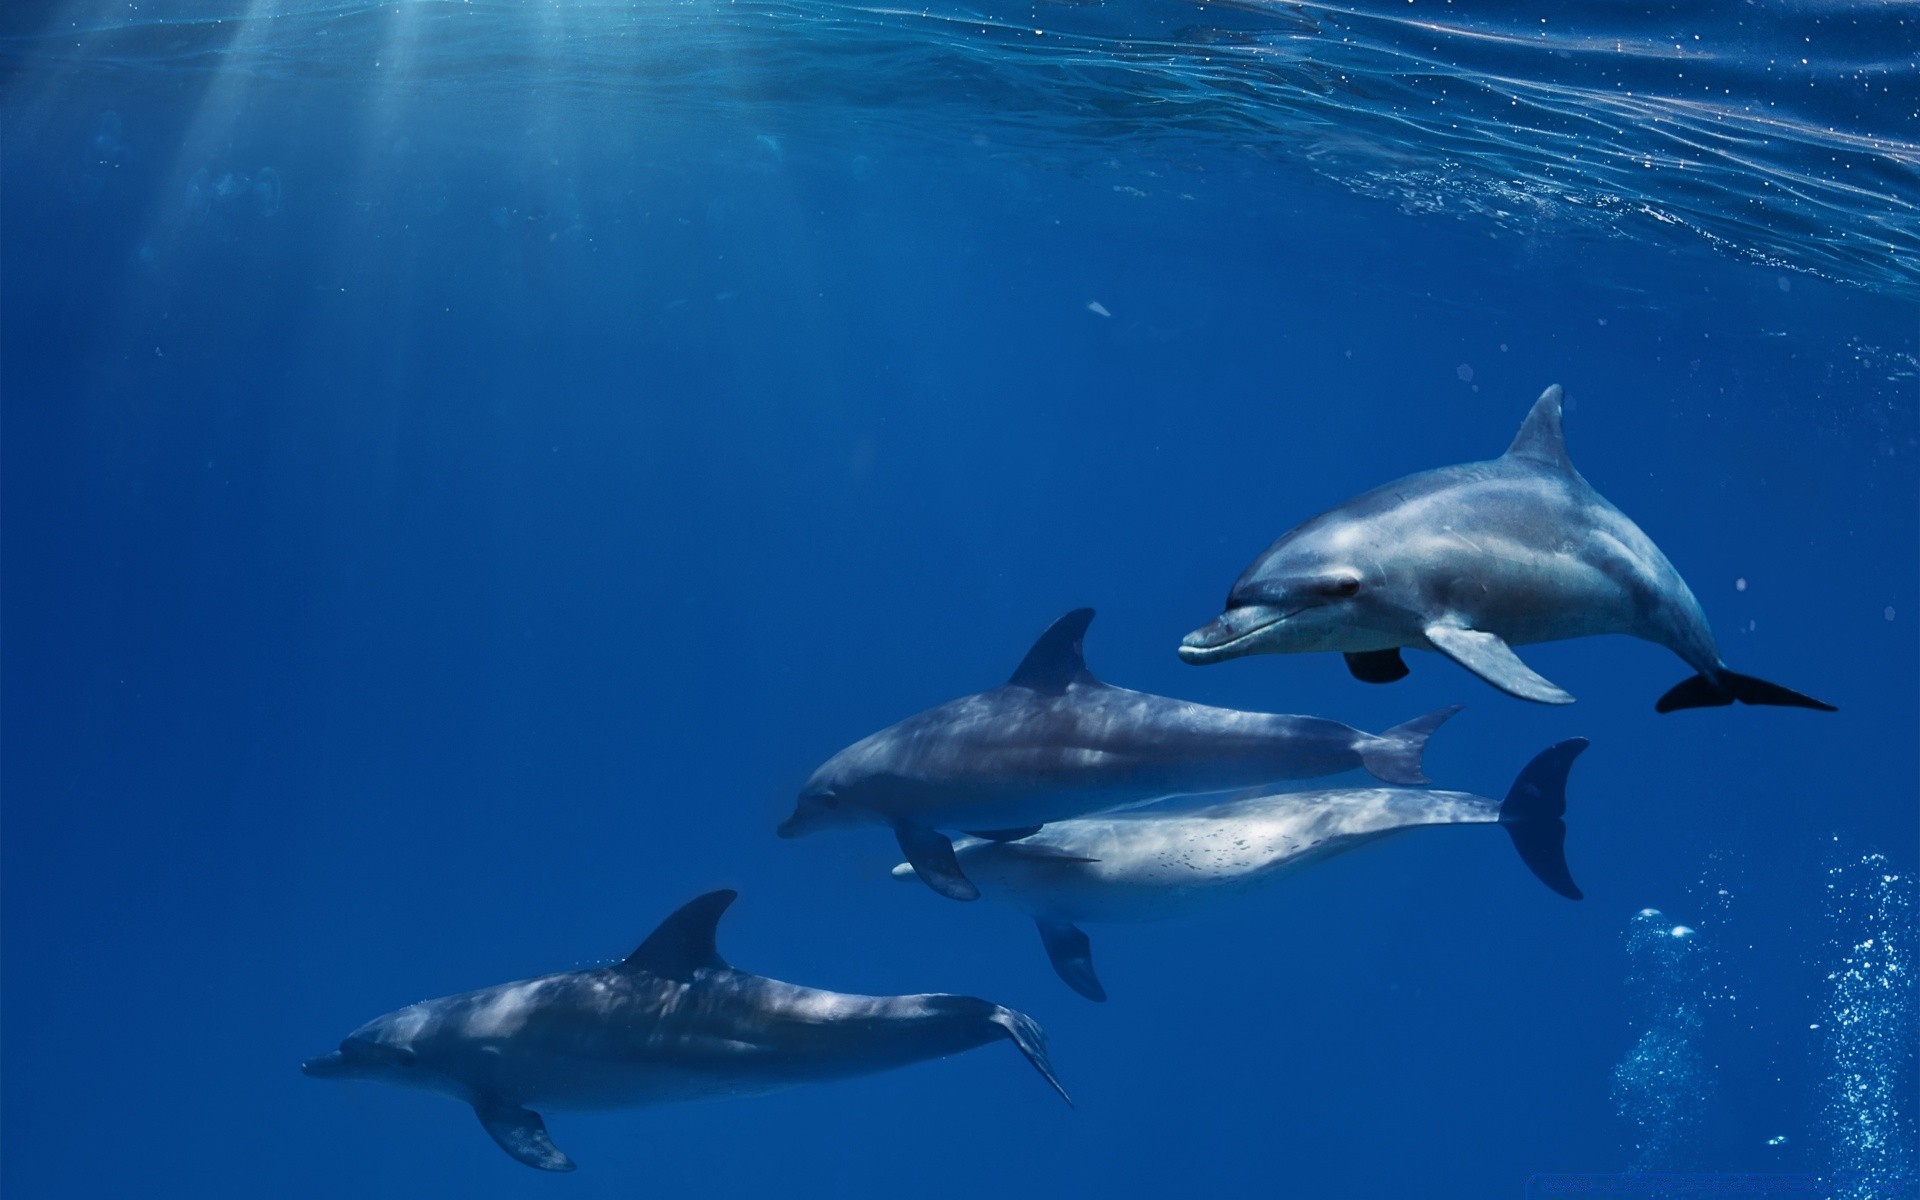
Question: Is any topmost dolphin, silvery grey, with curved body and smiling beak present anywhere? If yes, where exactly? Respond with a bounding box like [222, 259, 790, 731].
[1181, 384, 1834, 712]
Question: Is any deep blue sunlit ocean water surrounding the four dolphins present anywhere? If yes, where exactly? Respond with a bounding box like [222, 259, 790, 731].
[0, 0, 1920, 1198]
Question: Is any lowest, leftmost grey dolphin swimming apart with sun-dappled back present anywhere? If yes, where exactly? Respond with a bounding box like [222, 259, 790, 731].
[301, 891, 1071, 1171]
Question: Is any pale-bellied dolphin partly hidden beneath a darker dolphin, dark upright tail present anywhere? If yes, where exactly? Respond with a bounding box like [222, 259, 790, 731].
[893, 737, 1588, 1000]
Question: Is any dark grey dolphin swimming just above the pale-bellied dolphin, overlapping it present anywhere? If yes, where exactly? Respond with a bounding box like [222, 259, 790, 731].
[780, 609, 1459, 900]
